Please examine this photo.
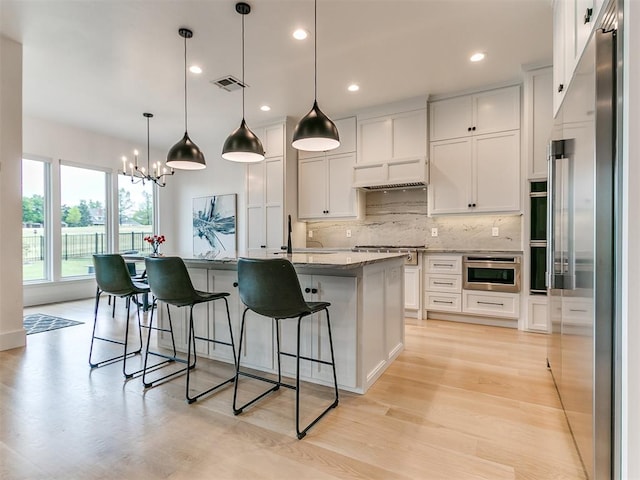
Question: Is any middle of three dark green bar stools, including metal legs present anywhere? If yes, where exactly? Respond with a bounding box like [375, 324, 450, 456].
[142, 257, 236, 403]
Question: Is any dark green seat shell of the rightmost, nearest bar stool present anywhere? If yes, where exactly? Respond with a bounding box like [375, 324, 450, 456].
[238, 258, 310, 318]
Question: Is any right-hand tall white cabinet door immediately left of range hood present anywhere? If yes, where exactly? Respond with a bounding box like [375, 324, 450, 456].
[328, 153, 358, 217]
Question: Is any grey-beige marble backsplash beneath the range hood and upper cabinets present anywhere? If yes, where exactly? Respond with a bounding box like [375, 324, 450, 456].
[307, 188, 523, 250]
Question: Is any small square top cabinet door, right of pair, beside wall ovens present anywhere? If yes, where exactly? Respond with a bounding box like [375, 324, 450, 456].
[472, 86, 520, 135]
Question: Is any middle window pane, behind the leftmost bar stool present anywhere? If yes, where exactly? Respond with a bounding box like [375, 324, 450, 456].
[60, 165, 109, 277]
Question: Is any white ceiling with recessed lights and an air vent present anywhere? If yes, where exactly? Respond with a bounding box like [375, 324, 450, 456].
[0, 0, 552, 153]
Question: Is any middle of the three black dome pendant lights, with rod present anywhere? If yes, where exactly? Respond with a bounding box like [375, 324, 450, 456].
[222, 2, 264, 163]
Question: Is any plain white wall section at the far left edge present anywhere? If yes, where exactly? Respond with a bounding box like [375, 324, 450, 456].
[0, 37, 25, 350]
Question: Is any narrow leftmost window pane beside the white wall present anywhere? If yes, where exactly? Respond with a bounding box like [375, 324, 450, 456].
[22, 159, 49, 282]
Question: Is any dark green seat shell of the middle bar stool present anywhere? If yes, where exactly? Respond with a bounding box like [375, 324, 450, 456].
[144, 257, 198, 306]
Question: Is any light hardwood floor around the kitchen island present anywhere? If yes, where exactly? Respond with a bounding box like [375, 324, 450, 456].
[0, 300, 584, 480]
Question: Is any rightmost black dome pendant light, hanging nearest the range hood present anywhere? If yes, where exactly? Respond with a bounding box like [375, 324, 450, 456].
[291, 0, 340, 152]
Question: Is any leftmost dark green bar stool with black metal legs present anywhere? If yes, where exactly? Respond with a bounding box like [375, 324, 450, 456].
[89, 253, 149, 378]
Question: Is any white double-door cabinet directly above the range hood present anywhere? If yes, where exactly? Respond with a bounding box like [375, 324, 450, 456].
[357, 106, 427, 164]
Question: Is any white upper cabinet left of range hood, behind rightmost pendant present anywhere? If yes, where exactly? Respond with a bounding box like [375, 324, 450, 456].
[298, 117, 358, 220]
